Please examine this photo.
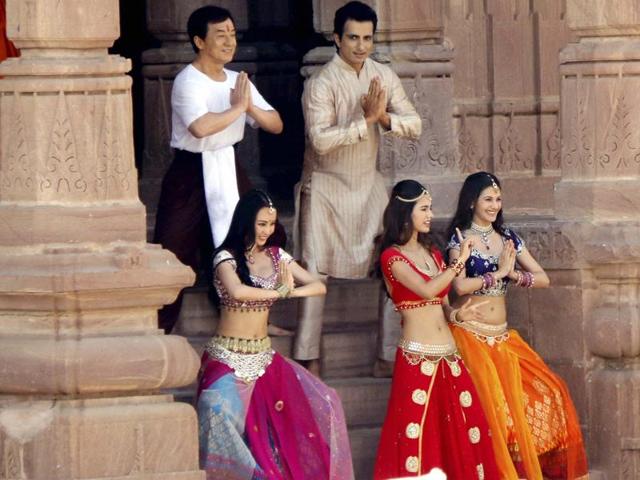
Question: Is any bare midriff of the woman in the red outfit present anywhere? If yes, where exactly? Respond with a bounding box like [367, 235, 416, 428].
[401, 305, 454, 345]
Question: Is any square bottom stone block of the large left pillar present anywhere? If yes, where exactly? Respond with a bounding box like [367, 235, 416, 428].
[0, 396, 205, 480]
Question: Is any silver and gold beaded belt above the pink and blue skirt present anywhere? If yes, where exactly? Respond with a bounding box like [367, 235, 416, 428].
[205, 335, 275, 383]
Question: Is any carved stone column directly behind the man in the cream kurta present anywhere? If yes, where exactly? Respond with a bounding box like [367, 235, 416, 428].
[302, 0, 457, 197]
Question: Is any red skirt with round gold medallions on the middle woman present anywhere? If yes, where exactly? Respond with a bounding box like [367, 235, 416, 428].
[374, 348, 499, 480]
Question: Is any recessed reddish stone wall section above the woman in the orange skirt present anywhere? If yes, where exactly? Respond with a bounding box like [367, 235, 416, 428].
[444, 0, 570, 216]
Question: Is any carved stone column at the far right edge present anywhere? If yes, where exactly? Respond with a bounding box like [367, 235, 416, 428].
[555, 0, 640, 479]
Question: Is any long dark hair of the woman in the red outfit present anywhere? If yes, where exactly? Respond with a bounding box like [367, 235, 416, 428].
[374, 180, 433, 276]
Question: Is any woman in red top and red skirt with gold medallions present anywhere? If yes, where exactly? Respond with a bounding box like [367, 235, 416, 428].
[374, 180, 499, 480]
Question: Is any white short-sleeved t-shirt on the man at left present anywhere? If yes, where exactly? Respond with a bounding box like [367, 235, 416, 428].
[171, 64, 273, 153]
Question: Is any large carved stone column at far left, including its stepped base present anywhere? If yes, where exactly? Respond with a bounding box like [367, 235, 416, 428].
[0, 0, 204, 480]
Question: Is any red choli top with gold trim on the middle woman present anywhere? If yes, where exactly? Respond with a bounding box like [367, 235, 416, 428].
[380, 247, 451, 310]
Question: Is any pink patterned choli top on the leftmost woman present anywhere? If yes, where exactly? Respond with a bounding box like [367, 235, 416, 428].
[213, 247, 293, 312]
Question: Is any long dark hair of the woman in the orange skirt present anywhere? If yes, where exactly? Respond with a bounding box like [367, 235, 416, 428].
[447, 172, 507, 244]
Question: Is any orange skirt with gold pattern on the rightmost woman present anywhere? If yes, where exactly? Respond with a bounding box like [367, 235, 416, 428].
[451, 325, 588, 480]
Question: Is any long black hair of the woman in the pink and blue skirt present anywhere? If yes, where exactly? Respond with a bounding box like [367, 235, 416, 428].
[213, 190, 282, 286]
